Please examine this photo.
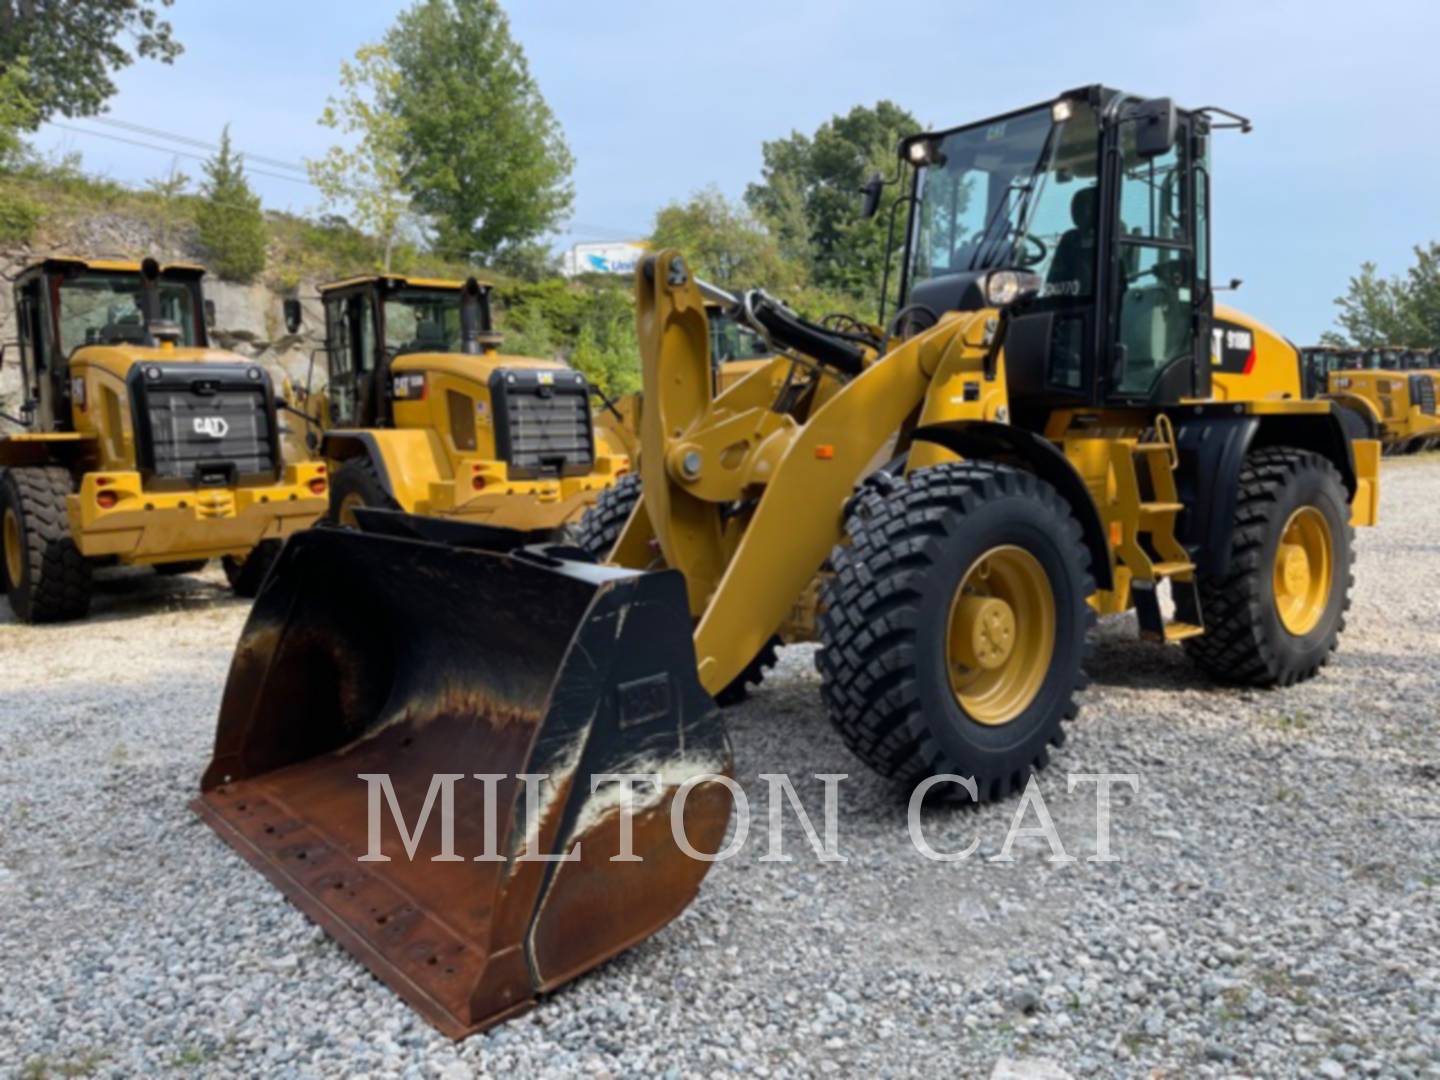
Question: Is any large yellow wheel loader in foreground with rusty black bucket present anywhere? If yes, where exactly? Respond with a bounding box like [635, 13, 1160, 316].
[196, 86, 1378, 1037]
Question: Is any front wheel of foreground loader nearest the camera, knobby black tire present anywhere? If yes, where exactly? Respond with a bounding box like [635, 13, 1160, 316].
[816, 462, 1094, 802]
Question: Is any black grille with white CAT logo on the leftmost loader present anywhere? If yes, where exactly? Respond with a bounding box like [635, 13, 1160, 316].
[128, 363, 279, 491]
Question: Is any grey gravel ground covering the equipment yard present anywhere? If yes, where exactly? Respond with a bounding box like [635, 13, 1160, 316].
[0, 455, 1440, 1079]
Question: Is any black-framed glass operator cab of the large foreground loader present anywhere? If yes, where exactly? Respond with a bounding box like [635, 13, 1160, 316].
[893, 86, 1228, 409]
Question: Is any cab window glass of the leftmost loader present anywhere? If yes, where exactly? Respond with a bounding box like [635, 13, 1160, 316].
[59, 271, 197, 356]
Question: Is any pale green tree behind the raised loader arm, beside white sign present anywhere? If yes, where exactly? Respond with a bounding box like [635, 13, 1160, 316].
[649, 187, 804, 292]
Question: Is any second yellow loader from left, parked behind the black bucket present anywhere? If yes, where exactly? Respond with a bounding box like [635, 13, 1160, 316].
[296, 275, 629, 530]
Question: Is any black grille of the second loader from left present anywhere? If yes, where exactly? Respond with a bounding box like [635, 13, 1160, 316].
[490, 369, 595, 480]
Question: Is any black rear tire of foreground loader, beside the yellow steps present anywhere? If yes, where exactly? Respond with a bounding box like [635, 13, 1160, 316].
[1185, 446, 1355, 687]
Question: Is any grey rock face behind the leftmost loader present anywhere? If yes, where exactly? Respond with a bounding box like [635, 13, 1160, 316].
[0, 215, 325, 433]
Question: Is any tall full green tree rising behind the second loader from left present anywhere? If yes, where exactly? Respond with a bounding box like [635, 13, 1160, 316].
[386, 0, 575, 261]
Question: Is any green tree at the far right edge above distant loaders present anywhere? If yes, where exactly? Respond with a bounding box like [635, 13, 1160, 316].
[1323, 240, 1440, 348]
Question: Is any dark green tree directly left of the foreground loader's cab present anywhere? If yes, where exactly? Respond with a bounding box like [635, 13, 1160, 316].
[744, 101, 920, 298]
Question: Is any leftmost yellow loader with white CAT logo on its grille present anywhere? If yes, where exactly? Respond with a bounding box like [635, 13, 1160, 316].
[0, 258, 327, 622]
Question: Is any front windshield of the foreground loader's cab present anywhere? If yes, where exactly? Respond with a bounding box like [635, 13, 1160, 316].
[909, 102, 1099, 297]
